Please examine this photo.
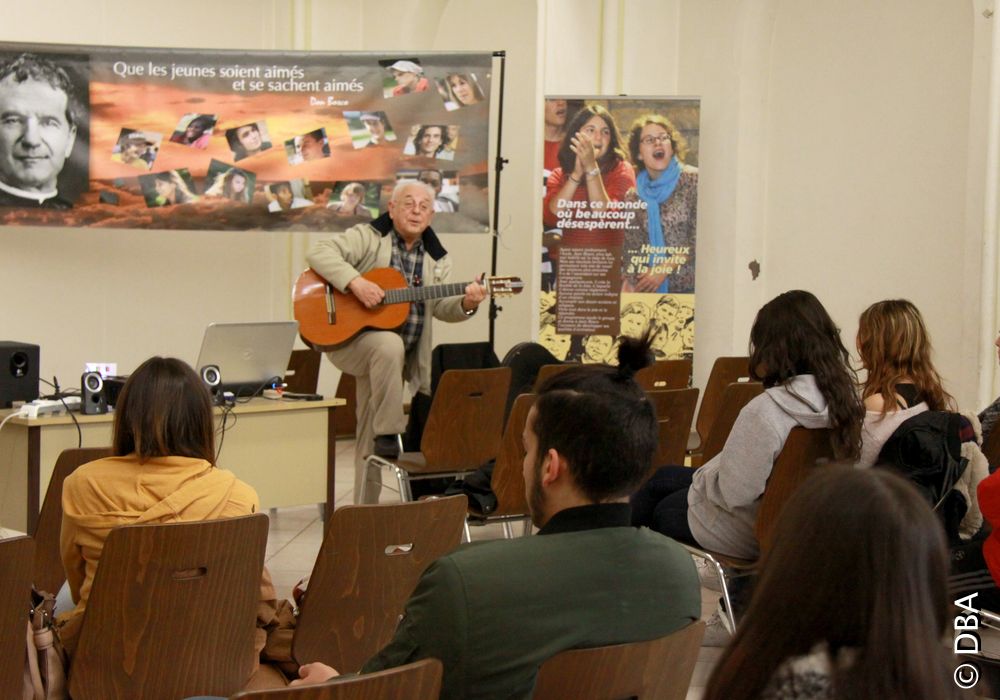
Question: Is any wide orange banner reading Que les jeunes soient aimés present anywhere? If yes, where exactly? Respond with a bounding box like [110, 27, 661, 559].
[0, 43, 493, 233]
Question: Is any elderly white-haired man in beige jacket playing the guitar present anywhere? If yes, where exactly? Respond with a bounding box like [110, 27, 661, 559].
[306, 180, 486, 503]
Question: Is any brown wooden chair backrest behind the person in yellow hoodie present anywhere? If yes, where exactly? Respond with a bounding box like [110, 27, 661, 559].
[69, 513, 267, 700]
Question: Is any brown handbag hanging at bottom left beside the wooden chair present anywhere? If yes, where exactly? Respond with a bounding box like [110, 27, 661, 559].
[22, 590, 69, 700]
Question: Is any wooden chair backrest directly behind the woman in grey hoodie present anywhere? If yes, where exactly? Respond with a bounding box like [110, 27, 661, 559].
[754, 426, 834, 554]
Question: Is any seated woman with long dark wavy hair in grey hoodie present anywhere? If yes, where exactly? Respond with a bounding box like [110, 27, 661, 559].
[632, 290, 863, 559]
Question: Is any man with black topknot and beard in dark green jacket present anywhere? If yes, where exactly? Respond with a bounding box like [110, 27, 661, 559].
[286, 340, 701, 698]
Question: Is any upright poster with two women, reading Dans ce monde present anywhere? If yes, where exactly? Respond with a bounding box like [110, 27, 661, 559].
[539, 97, 700, 364]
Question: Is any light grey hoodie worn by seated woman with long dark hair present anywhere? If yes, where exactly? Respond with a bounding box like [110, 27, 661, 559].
[688, 374, 830, 559]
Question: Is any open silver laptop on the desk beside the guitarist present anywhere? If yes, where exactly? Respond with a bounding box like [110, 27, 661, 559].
[195, 321, 299, 396]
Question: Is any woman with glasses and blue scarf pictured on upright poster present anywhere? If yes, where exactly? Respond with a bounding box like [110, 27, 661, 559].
[622, 114, 698, 294]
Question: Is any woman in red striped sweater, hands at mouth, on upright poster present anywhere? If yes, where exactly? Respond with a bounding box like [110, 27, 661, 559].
[543, 105, 635, 246]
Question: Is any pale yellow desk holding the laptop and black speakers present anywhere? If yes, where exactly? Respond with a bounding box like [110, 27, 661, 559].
[0, 398, 345, 533]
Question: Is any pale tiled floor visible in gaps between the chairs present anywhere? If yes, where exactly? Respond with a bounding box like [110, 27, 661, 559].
[267, 440, 722, 700]
